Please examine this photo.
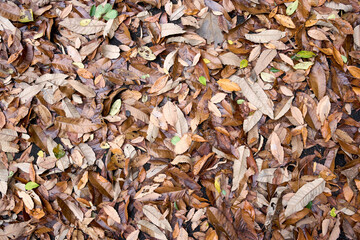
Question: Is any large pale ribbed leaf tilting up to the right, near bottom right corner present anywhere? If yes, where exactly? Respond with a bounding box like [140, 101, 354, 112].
[285, 178, 325, 217]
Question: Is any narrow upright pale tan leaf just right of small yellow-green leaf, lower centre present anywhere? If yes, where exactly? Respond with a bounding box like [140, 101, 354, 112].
[231, 146, 250, 191]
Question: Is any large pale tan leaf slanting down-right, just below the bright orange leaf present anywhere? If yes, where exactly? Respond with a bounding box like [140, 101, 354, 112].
[230, 76, 274, 119]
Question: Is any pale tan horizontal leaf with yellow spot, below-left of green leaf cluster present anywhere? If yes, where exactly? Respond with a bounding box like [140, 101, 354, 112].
[59, 18, 106, 35]
